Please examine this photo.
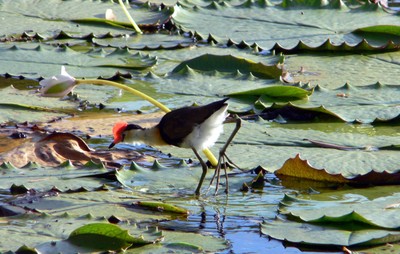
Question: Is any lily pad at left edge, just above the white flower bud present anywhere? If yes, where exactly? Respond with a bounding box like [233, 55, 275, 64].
[0, 44, 157, 78]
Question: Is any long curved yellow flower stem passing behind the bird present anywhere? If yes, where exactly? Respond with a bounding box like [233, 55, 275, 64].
[75, 79, 218, 167]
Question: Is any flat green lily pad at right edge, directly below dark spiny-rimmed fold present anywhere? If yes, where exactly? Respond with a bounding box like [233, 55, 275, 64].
[285, 52, 400, 89]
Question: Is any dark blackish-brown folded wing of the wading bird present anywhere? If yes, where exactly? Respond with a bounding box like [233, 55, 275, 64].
[158, 98, 229, 146]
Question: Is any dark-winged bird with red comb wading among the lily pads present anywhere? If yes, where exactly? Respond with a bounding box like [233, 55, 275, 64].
[109, 98, 241, 195]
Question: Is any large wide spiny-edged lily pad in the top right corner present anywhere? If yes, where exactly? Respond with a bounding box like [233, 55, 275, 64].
[174, 1, 399, 49]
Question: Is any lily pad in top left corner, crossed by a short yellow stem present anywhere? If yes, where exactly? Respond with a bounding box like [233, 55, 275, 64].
[0, 0, 172, 38]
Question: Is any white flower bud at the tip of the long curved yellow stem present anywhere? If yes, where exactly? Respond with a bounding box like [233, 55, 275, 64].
[39, 66, 77, 97]
